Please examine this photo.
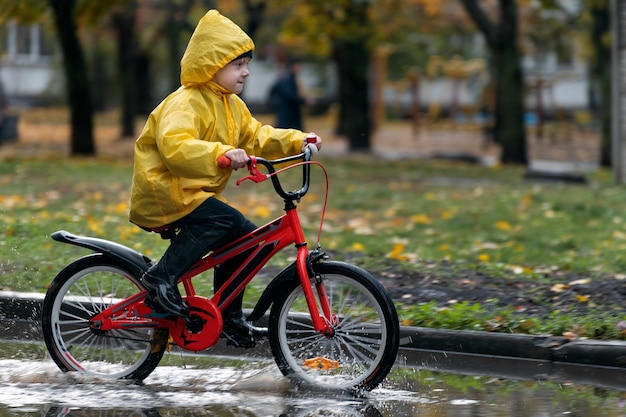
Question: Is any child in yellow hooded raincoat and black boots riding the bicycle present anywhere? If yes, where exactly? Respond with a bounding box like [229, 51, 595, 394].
[129, 10, 321, 348]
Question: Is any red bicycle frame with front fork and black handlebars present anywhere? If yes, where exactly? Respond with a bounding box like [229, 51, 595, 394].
[91, 148, 334, 346]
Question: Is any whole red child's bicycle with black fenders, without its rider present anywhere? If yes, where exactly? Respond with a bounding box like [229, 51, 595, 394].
[42, 148, 399, 390]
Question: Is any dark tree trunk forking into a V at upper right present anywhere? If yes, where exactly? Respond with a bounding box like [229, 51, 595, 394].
[459, 0, 527, 164]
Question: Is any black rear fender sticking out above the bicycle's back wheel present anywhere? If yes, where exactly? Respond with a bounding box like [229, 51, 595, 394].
[52, 230, 152, 277]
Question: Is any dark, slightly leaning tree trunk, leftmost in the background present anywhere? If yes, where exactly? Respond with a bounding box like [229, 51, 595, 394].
[50, 0, 96, 155]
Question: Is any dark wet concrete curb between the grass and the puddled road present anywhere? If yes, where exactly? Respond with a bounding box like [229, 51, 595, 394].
[0, 291, 626, 368]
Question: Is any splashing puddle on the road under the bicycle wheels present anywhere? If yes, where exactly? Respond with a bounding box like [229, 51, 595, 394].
[0, 358, 626, 417]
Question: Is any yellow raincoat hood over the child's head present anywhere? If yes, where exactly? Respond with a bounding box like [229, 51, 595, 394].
[180, 10, 254, 87]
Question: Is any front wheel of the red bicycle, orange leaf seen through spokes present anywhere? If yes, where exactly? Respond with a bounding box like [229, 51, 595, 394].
[268, 261, 400, 391]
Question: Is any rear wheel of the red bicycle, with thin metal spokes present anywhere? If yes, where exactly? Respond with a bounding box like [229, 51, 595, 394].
[42, 254, 169, 381]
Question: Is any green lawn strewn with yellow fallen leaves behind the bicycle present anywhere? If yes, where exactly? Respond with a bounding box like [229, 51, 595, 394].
[0, 157, 626, 337]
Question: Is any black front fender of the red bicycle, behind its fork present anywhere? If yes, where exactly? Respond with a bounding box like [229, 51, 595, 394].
[246, 250, 328, 321]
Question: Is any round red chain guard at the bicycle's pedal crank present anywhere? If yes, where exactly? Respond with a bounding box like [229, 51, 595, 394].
[170, 296, 223, 352]
